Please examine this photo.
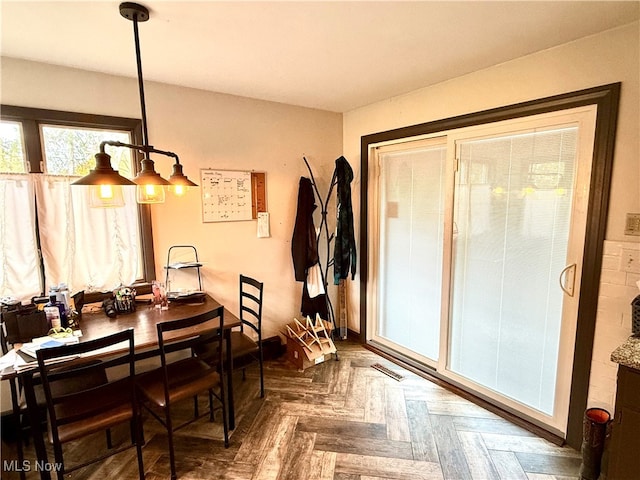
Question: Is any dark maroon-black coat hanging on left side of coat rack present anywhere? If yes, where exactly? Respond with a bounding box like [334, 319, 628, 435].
[291, 177, 328, 319]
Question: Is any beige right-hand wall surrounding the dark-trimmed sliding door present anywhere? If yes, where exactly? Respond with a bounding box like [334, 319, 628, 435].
[344, 22, 640, 408]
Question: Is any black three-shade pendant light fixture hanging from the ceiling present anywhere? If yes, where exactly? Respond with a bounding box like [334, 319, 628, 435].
[73, 2, 197, 207]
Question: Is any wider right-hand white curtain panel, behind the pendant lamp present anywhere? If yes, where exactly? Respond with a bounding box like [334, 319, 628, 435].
[34, 174, 142, 292]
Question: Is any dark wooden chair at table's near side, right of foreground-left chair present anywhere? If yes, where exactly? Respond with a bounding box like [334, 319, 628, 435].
[136, 306, 229, 480]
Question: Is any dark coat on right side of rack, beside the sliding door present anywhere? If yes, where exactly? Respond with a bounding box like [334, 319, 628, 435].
[333, 157, 356, 285]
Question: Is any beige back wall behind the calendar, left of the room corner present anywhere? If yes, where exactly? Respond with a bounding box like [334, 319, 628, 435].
[1, 58, 342, 342]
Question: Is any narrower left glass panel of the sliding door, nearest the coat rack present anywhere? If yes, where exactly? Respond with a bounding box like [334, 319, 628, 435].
[378, 138, 446, 365]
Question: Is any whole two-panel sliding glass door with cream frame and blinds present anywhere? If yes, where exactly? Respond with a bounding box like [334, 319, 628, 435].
[368, 108, 595, 434]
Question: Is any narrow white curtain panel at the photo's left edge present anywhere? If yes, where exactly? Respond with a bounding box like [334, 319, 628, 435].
[0, 174, 42, 301]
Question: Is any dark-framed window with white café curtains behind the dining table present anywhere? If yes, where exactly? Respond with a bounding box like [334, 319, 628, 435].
[0, 106, 155, 301]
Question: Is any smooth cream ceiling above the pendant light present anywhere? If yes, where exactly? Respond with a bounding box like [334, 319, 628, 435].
[0, 0, 640, 112]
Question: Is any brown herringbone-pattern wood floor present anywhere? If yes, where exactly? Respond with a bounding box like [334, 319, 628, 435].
[2, 341, 580, 480]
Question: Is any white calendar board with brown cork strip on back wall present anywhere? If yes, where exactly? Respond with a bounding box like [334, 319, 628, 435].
[200, 168, 266, 223]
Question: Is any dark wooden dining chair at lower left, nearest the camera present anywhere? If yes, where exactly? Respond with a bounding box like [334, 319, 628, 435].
[36, 328, 144, 479]
